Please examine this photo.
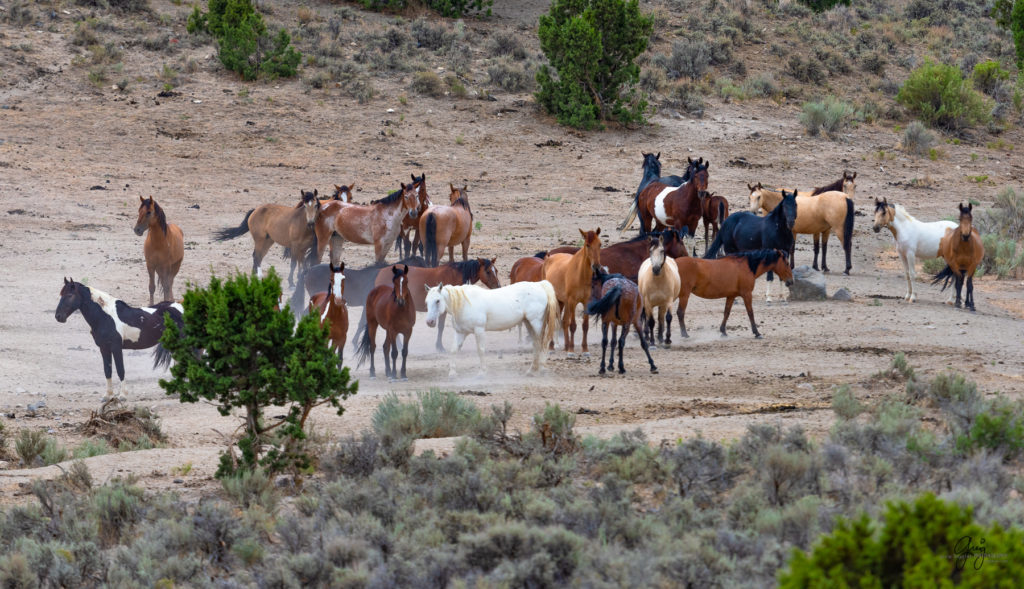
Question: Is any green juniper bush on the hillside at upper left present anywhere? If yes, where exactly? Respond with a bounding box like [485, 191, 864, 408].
[187, 0, 302, 80]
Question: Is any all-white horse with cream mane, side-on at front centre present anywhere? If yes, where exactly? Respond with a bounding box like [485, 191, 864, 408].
[427, 281, 561, 376]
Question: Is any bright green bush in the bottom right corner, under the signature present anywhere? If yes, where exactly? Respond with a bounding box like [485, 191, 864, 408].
[779, 493, 1024, 588]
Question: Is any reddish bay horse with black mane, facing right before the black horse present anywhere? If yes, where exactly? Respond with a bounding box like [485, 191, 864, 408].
[676, 249, 793, 339]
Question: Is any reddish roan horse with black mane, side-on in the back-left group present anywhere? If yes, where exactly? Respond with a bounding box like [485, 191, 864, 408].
[315, 177, 419, 263]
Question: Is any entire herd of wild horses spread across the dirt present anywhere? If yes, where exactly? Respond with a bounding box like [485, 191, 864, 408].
[55, 154, 983, 395]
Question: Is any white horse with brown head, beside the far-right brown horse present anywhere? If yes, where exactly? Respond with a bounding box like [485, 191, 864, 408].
[871, 199, 956, 302]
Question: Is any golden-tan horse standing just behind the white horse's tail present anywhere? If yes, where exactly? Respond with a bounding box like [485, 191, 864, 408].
[541, 227, 601, 355]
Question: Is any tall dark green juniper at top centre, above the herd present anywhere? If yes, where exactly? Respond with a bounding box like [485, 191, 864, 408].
[537, 0, 653, 129]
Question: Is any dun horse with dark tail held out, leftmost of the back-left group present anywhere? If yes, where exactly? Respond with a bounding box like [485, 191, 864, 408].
[214, 190, 323, 286]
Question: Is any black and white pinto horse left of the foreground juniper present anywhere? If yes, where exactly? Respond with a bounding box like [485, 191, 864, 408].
[54, 279, 183, 398]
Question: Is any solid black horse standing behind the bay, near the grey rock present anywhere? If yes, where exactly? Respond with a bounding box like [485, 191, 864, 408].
[708, 191, 797, 302]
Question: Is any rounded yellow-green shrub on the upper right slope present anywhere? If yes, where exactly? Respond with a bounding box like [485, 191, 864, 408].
[896, 61, 989, 131]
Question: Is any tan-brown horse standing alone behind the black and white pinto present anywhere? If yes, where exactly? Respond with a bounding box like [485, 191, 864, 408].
[135, 197, 185, 304]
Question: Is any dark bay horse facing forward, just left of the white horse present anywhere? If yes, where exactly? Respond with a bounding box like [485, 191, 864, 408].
[352, 264, 416, 380]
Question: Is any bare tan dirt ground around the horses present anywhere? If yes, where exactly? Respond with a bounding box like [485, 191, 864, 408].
[0, 2, 1024, 500]
